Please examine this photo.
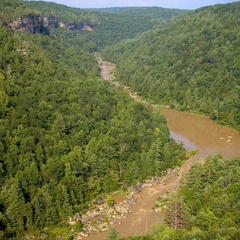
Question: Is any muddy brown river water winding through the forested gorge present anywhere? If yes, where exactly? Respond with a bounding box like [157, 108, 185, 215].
[84, 57, 240, 240]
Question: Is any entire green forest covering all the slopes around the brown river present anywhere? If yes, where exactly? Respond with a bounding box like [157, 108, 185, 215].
[0, 0, 240, 240]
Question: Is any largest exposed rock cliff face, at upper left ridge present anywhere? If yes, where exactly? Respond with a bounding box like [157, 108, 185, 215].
[9, 15, 44, 34]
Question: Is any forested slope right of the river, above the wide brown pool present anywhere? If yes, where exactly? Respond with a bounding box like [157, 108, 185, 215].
[102, 2, 240, 129]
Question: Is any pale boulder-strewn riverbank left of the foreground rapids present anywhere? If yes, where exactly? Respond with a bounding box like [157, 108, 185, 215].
[69, 168, 179, 240]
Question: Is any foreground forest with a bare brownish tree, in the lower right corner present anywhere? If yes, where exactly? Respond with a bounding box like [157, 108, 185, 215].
[118, 156, 240, 240]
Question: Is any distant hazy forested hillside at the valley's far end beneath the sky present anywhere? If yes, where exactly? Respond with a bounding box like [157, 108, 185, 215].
[23, 1, 185, 51]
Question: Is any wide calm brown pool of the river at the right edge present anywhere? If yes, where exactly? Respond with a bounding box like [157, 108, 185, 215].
[162, 109, 240, 159]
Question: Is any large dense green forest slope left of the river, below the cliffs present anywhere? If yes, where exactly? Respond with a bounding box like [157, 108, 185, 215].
[0, 0, 186, 239]
